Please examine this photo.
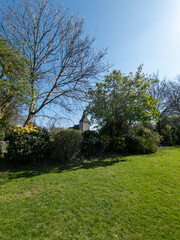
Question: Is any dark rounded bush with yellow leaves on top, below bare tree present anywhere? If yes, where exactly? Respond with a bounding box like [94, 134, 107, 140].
[6, 125, 50, 165]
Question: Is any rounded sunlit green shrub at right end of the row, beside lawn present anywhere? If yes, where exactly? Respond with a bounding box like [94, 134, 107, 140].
[126, 124, 160, 154]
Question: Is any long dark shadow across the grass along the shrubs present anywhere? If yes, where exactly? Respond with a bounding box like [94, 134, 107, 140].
[0, 156, 127, 184]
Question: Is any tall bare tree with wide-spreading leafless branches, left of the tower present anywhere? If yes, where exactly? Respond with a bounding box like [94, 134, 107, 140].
[0, 0, 108, 124]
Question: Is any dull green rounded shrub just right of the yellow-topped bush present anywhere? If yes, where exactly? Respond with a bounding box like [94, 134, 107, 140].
[51, 129, 82, 163]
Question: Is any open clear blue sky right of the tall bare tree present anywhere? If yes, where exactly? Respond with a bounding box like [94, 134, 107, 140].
[63, 0, 180, 80]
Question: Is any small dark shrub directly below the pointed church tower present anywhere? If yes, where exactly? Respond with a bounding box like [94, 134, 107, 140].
[81, 130, 105, 157]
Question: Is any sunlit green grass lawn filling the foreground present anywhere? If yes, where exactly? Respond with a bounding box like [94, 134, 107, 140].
[0, 147, 180, 240]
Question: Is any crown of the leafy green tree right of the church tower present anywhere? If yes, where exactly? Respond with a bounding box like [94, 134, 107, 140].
[87, 65, 159, 135]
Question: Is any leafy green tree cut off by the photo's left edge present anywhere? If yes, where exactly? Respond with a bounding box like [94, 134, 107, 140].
[0, 37, 29, 138]
